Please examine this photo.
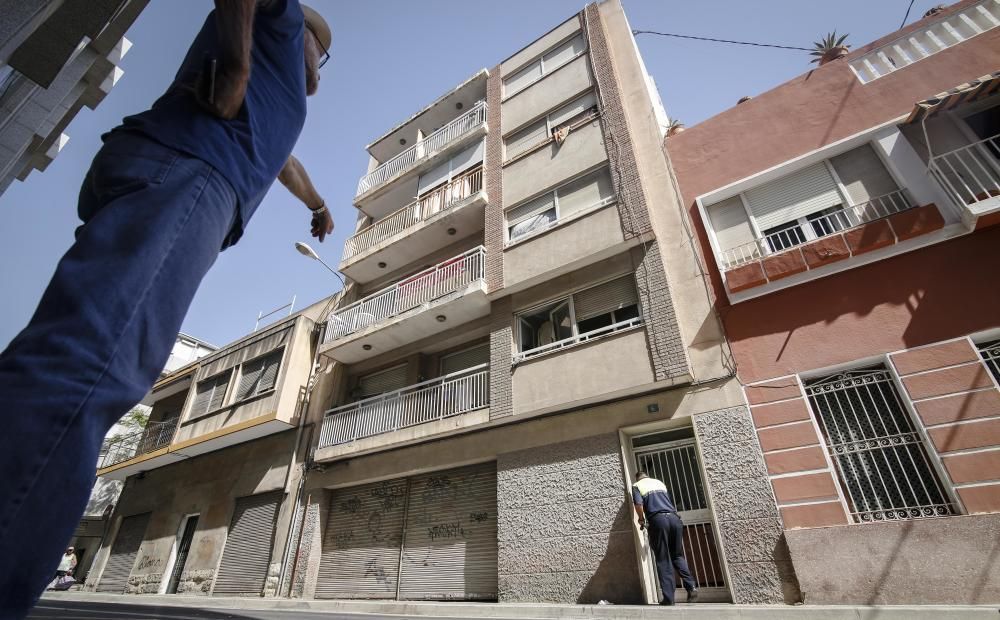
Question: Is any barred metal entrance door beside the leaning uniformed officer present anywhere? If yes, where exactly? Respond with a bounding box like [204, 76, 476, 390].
[635, 439, 728, 600]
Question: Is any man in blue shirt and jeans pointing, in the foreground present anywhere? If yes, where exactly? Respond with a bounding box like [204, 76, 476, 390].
[0, 0, 333, 618]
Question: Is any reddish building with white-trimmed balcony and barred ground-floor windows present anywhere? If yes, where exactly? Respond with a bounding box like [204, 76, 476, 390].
[664, 0, 1000, 604]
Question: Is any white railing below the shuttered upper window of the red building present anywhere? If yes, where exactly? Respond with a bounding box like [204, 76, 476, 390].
[719, 189, 913, 269]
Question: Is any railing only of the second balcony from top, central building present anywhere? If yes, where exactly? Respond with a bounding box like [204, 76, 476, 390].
[342, 168, 483, 261]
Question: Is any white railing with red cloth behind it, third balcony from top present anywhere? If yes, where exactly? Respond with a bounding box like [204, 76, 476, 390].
[323, 246, 486, 343]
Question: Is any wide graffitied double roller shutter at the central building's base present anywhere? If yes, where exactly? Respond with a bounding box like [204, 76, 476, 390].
[316, 463, 497, 600]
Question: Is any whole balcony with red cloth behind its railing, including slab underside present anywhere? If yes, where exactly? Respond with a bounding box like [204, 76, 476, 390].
[322, 246, 490, 364]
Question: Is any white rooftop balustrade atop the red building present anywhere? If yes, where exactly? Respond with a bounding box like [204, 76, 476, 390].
[850, 0, 1000, 84]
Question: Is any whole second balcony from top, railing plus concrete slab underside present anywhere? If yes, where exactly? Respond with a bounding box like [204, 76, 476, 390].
[340, 167, 487, 282]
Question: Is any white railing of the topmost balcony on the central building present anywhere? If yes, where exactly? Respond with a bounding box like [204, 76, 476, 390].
[354, 102, 486, 205]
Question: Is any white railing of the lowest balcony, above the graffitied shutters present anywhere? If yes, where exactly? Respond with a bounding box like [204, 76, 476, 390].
[319, 364, 490, 448]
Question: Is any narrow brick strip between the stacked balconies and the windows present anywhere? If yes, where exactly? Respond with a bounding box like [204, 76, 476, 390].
[483, 65, 504, 292]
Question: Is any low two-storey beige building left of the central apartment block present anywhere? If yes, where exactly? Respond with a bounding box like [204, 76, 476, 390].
[85, 299, 332, 596]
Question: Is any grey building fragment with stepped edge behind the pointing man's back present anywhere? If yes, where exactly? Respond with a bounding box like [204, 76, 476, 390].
[0, 0, 149, 194]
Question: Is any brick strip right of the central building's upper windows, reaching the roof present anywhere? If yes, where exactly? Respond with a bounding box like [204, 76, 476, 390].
[582, 4, 652, 239]
